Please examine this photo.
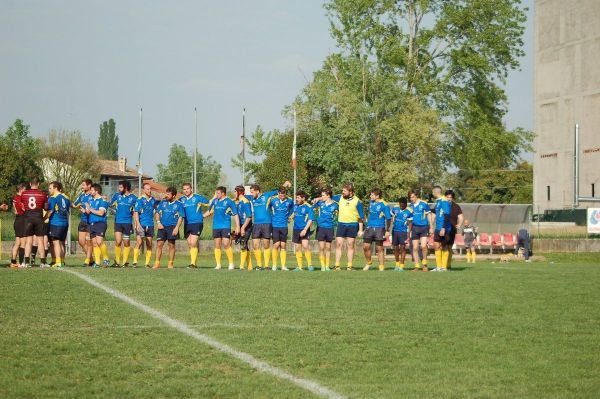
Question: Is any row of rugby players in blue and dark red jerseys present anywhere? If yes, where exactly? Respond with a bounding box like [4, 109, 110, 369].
[5, 179, 464, 271]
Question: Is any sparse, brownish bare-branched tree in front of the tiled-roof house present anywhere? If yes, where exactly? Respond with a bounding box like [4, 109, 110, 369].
[39, 129, 100, 196]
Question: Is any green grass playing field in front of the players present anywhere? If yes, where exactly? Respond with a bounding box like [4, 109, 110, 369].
[0, 254, 600, 398]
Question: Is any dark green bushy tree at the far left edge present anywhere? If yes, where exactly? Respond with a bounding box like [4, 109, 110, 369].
[0, 119, 41, 202]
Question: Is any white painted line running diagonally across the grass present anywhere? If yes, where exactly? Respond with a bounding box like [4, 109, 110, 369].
[59, 269, 344, 399]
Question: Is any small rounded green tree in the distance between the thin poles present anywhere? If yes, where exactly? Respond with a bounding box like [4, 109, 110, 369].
[157, 144, 224, 195]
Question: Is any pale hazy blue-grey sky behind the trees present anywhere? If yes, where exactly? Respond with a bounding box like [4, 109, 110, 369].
[0, 0, 533, 185]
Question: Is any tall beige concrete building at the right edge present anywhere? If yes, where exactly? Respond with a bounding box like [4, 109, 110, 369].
[533, 0, 600, 212]
